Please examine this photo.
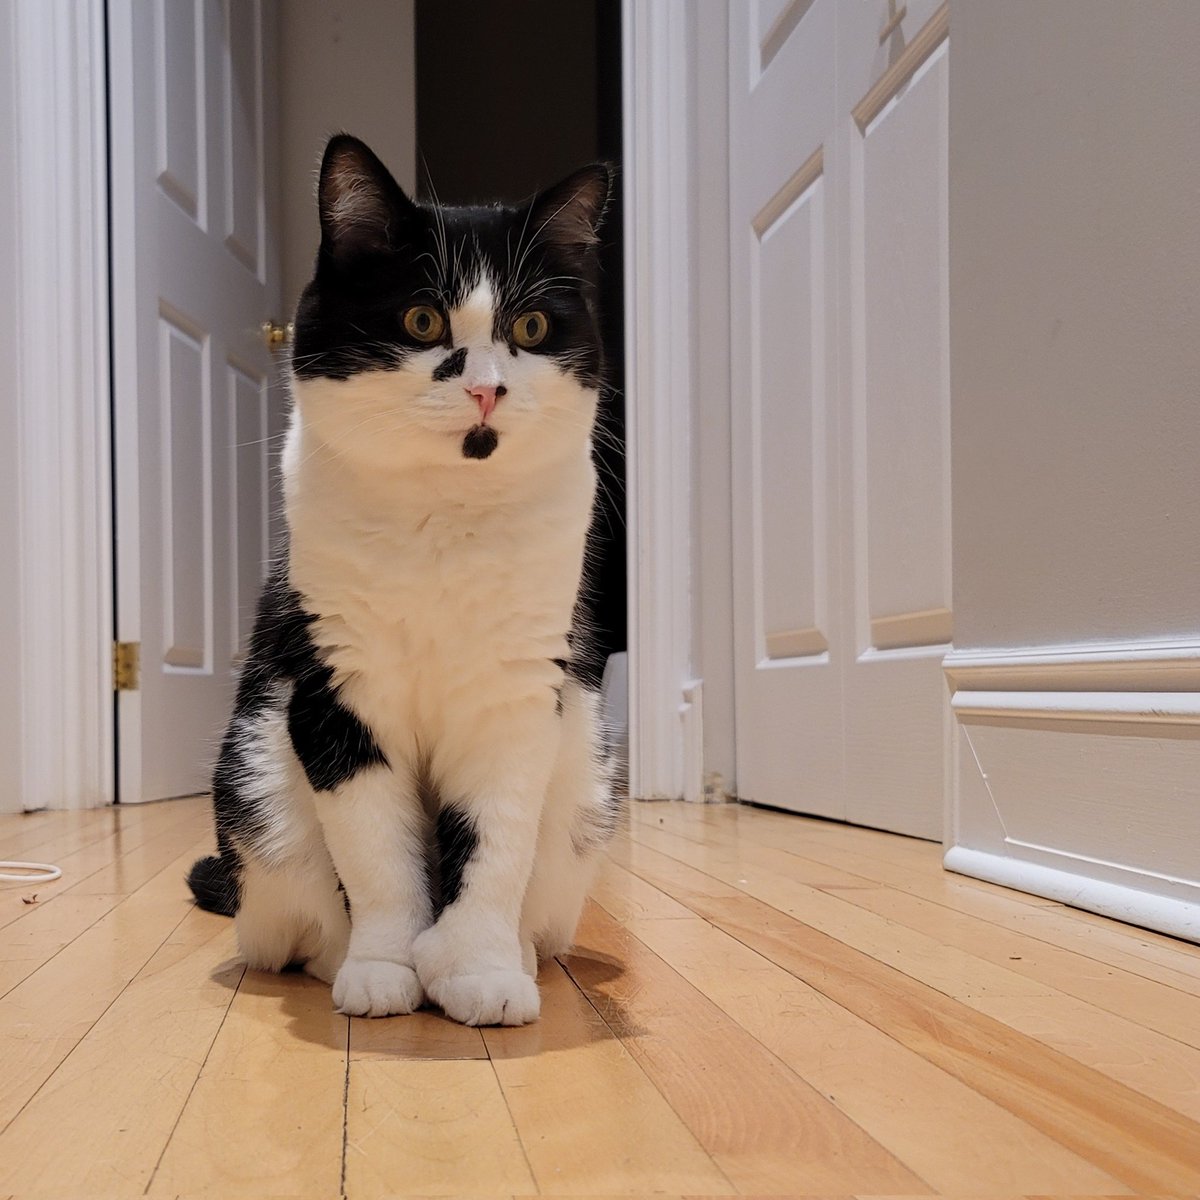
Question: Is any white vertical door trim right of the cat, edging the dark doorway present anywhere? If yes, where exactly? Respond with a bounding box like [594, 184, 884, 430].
[622, 0, 702, 799]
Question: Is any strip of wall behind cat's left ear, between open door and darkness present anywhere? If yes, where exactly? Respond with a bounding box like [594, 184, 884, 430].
[280, 0, 416, 314]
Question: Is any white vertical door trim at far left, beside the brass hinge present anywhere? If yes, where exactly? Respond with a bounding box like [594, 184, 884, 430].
[13, 0, 115, 809]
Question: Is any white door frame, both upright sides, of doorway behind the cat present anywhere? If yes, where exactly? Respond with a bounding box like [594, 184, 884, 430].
[0, 0, 701, 809]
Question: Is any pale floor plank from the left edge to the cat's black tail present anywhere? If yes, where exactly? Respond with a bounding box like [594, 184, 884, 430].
[0, 847, 214, 1129]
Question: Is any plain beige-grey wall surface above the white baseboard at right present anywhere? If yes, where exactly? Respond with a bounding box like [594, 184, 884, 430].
[949, 0, 1200, 648]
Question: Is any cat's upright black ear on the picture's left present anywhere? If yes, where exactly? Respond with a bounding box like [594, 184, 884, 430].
[317, 133, 416, 260]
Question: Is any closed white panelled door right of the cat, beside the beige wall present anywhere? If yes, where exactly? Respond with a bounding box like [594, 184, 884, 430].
[730, 0, 952, 838]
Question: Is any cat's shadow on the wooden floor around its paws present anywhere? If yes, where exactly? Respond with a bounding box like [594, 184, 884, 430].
[210, 947, 640, 1060]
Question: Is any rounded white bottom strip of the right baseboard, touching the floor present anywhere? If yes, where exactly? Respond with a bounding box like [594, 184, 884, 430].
[944, 846, 1200, 942]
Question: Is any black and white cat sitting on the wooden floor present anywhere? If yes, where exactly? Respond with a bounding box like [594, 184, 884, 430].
[188, 134, 619, 1025]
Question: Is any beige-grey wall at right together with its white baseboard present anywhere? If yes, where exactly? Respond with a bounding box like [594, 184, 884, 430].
[946, 0, 1200, 940]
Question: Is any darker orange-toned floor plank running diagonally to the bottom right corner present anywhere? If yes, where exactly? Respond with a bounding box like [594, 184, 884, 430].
[614, 849, 1200, 1194]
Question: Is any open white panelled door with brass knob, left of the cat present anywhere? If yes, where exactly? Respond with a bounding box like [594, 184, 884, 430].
[109, 0, 280, 802]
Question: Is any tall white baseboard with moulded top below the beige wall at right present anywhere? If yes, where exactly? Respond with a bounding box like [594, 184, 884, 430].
[944, 641, 1200, 941]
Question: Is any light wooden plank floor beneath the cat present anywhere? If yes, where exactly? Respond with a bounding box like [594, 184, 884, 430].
[0, 800, 1200, 1198]
